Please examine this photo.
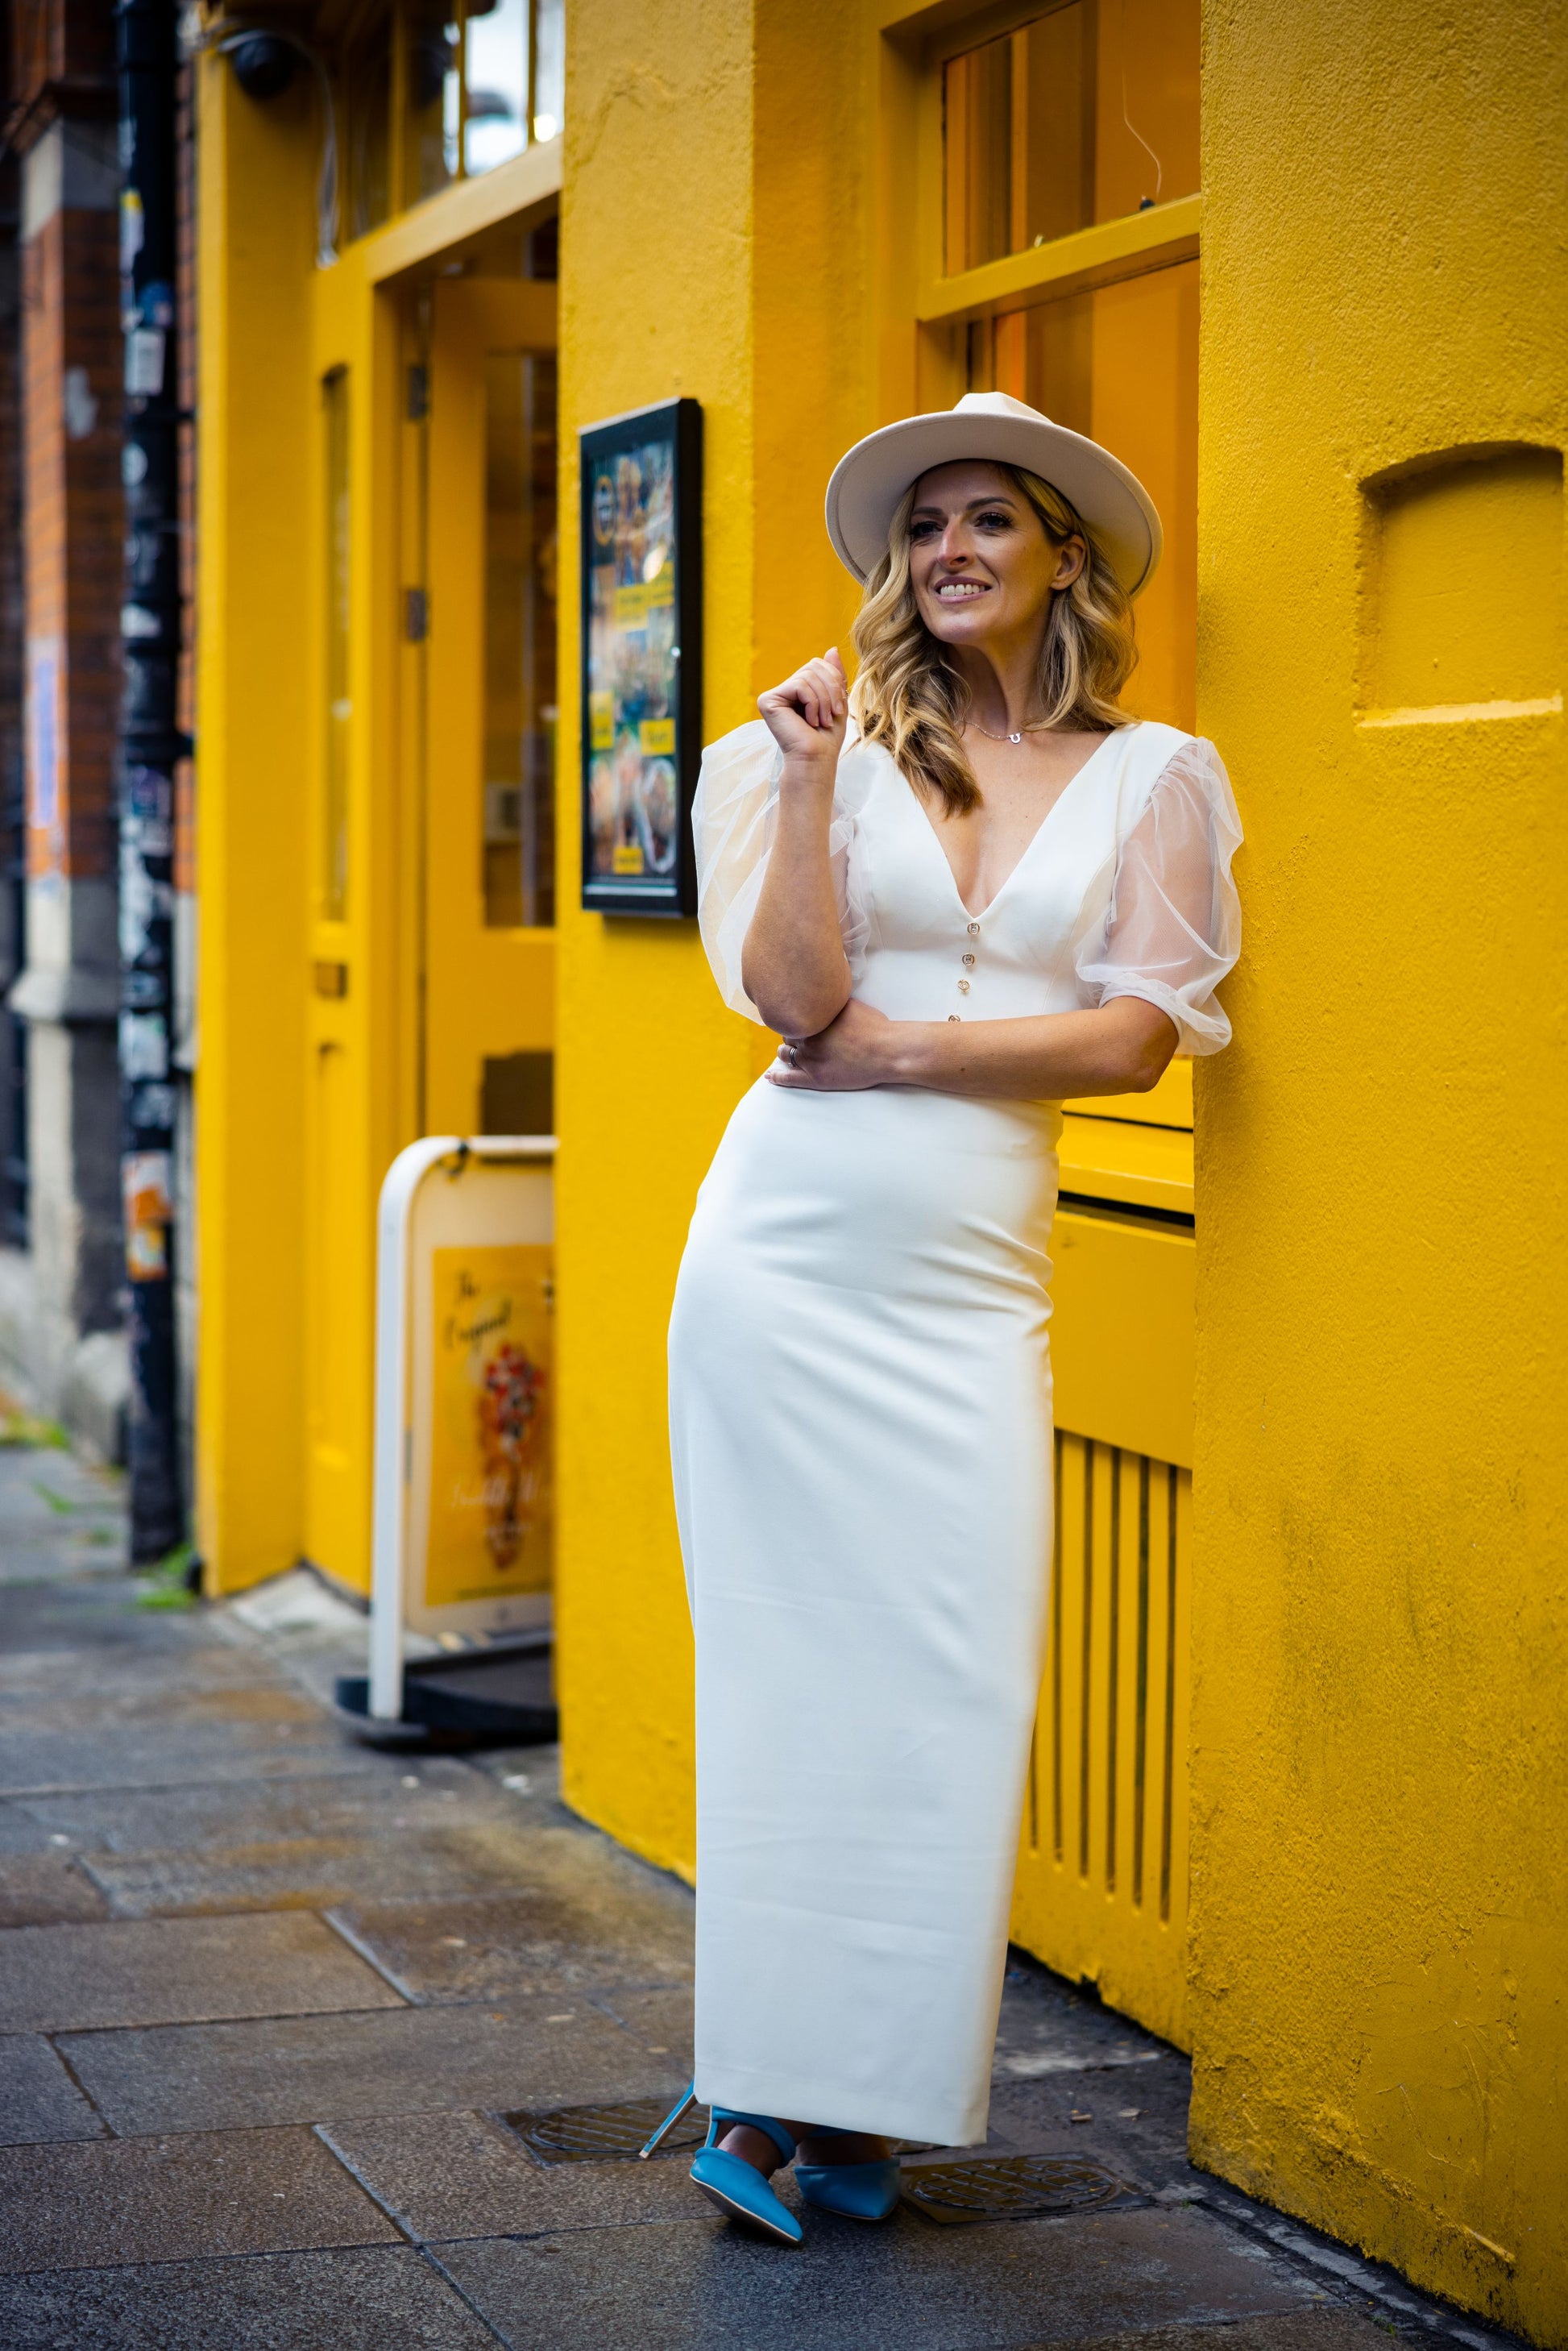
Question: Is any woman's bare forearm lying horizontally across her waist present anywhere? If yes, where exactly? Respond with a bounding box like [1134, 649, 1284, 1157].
[881, 997, 1178, 1103]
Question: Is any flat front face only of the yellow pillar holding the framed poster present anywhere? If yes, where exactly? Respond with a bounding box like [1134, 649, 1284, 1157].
[555, 0, 753, 1869]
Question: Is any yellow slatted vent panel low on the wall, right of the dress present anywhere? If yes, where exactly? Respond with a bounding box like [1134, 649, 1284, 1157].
[1013, 1430, 1192, 2048]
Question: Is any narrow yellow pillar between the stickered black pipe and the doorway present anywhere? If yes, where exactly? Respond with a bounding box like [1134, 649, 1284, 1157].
[195, 56, 317, 1589]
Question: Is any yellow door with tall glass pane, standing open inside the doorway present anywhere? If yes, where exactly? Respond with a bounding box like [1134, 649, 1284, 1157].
[423, 277, 557, 1136]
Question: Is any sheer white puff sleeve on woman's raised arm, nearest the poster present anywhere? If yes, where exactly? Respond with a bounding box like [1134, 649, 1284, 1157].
[691, 720, 869, 1028]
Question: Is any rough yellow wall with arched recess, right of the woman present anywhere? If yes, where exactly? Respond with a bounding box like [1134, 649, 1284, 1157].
[1192, 0, 1568, 2344]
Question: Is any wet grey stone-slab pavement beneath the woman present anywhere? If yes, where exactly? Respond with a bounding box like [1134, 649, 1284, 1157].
[0, 1448, 1533, 2351]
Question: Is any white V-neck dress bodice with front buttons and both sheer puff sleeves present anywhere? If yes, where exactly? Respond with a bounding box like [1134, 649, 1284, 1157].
[694, 720, 1241, 1053]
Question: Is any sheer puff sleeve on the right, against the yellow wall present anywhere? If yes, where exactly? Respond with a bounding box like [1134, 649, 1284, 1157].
[1076, 736, 1241, 1053]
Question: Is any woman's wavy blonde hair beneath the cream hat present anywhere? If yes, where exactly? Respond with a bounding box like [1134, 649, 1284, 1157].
[851, 466, 1138, 816]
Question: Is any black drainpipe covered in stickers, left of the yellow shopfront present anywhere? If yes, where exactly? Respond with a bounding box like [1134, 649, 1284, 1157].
[115, 0, 185, 1564]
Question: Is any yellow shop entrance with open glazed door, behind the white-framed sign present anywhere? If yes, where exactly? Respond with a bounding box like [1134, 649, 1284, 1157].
[305, 257, 557, 1585]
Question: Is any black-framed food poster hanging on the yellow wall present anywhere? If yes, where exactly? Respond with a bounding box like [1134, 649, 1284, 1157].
[581, 400, 703, 915]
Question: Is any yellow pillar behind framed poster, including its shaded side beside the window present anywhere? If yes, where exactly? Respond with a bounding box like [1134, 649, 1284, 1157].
[557, 0, 874, 1876]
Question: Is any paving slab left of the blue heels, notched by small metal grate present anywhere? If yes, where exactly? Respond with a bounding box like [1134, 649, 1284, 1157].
[320, 2113, 710, 2243]
